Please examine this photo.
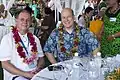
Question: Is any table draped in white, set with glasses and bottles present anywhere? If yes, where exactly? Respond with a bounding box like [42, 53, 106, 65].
[31, 56, 120, 80]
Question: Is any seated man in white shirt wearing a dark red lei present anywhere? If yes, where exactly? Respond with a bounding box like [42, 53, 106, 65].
[0, 9, 44, 80]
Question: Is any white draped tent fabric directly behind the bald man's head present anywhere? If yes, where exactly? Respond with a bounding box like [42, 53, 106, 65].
[52, 0, 85, 21]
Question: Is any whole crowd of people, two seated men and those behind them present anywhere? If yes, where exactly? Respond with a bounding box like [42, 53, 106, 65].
[0, 0, 120, 80]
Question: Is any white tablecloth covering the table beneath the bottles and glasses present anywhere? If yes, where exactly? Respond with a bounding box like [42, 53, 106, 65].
[32, 56, 120, 80]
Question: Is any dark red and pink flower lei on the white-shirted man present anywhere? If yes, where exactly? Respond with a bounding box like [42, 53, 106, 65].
[12, 28, 38, 64]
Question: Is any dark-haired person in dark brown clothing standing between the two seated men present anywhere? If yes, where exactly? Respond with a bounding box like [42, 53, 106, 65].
[40, 7, 56, 48]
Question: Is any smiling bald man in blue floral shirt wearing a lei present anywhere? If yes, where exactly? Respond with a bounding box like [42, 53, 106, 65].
[44, 8, 99, 64]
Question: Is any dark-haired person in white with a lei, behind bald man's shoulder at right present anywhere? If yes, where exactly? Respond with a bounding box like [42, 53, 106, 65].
[78, 7, 93, 28]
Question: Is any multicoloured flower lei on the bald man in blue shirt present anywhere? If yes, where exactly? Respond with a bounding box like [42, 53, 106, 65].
[58, 23, 80, 57]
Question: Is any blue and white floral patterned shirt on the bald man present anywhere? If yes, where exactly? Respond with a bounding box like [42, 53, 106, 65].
[44, 28, 99, 61]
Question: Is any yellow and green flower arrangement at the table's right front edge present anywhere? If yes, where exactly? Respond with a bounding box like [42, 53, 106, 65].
[105, 68, 120, 80]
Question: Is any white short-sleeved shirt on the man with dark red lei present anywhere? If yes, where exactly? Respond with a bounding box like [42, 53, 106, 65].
[0, 32, 44, 80]
